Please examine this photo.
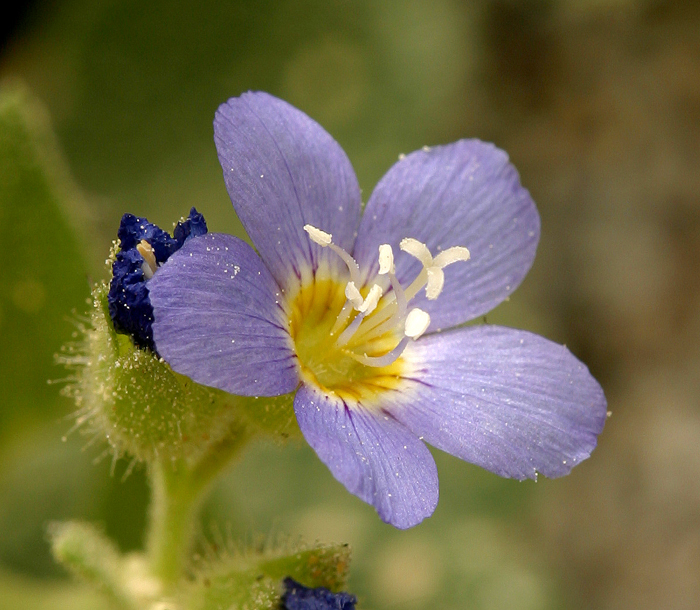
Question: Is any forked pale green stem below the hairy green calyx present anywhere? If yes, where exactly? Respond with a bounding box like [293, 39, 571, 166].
[146, 420, 250, 590]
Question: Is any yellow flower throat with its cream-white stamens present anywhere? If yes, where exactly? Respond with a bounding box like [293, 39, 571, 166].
[290, 225, 469, 398]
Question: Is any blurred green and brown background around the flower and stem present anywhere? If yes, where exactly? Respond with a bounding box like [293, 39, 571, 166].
[0, 0, 700, 610]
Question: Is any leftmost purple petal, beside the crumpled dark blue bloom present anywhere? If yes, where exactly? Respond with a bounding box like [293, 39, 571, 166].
[148, 233, 299, 396]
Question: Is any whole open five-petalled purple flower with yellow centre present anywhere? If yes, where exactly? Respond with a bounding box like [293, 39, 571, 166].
[149, 93, 606, 528]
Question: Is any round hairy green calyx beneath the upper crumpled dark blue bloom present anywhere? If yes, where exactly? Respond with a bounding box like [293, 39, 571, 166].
[68, 283, 299, 469]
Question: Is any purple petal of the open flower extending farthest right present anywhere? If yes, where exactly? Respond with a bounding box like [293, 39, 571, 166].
[389, 325, 607, 480]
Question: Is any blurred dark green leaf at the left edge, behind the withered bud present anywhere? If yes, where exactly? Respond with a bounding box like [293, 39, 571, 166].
[0, 87, 90, 434]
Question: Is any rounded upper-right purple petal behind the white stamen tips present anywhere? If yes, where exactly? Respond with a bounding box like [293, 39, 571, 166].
[354, 140, 540, 331]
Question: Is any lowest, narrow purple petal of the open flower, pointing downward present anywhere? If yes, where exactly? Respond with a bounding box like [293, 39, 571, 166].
[294, 383, 438, 529]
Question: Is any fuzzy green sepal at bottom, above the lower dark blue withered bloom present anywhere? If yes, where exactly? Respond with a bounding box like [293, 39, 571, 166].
[183, 544, 350, 610]
